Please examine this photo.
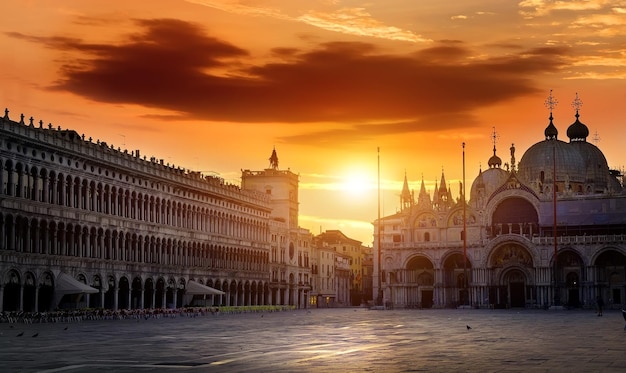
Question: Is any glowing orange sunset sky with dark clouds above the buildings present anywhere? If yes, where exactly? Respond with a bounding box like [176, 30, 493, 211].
[0, 0, 626, 246]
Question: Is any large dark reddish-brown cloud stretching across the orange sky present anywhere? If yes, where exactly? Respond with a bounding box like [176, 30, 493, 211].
[9, 19, 567, 133]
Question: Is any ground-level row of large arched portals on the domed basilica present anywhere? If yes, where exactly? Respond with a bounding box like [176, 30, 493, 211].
[382, 242, 626, 307]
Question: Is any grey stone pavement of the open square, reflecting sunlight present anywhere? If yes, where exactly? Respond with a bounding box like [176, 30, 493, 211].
[0, 308, 626, 373]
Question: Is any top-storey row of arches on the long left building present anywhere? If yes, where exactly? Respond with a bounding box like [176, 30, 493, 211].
[0, 158, 269, 240]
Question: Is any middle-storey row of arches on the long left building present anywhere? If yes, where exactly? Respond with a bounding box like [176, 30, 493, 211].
[0, 214, 269, 273]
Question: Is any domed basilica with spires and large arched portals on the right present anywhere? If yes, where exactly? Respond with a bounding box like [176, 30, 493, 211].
[374, 95, 626, 308]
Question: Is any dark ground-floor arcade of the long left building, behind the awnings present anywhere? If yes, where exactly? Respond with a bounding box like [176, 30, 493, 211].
[0, 269, 306, 312]
